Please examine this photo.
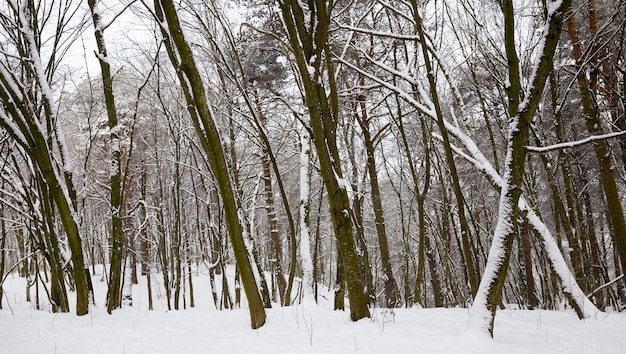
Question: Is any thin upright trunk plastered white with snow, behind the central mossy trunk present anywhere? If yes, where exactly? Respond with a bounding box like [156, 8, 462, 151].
[299, 130, 314, 301]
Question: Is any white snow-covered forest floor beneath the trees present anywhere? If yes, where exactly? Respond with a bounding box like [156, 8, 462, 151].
[0, 268, 626, 354]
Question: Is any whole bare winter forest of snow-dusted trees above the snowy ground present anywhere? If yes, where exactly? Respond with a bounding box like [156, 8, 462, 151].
[0, 0, 626, 342]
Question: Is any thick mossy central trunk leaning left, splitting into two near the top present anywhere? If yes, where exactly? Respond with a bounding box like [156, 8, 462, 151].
[280, 0, 370, 321]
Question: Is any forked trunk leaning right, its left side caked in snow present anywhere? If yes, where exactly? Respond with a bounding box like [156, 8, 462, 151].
[468, 0, 571, 336]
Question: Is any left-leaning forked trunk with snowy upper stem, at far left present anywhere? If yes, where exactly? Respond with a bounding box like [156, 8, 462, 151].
[0, 6, 89, 316]
